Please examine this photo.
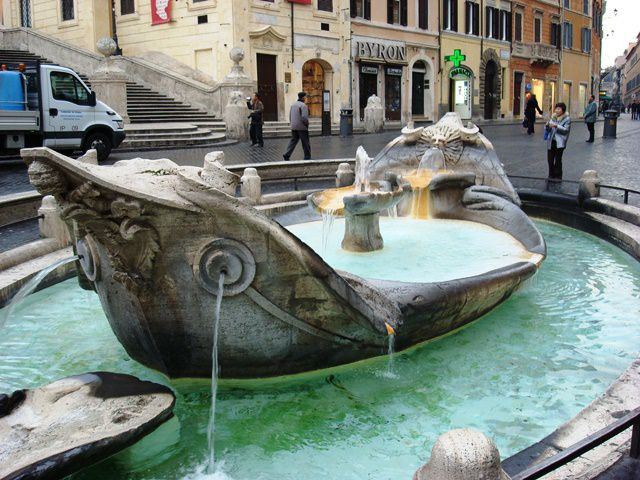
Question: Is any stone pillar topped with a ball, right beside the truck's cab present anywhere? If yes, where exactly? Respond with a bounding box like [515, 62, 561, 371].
[89, 37, 129, 123]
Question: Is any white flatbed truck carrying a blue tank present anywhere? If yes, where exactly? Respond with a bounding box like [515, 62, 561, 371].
[0, 62, 125, 161]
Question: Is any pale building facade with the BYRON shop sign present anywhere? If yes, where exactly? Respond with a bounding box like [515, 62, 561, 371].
[351, 0, 439, 124]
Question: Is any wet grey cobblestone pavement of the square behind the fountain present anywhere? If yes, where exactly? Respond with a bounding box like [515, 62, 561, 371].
[0, 114, 640, 195]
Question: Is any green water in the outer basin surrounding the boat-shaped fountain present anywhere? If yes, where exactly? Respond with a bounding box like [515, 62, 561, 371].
[0, 222, 640, 480]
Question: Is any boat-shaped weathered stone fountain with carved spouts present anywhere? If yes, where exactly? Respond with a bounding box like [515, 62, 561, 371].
[22, 114, 546, 378]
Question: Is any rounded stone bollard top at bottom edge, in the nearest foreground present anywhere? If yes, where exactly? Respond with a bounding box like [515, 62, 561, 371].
[413, 428, 510, 480]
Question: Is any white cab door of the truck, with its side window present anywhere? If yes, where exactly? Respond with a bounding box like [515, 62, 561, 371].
[42, 70, 95, 149]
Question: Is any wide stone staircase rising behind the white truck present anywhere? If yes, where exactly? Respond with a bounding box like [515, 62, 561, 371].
[0, 49, 226, 148]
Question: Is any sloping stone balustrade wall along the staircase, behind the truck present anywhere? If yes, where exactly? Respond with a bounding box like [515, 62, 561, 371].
[0, 28, 239, 117]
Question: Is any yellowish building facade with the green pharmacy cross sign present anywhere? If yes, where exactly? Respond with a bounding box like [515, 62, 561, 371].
[439, 0, 512, 119]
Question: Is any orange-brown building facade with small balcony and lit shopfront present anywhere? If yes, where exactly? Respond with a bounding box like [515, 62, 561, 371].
[510, 0, 561, 117]
